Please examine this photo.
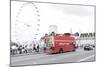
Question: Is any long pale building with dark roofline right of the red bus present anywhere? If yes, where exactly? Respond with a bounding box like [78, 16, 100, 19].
[75, 32, 95, 46]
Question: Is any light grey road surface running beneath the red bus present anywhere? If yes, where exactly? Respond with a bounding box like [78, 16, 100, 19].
[11, 49, 95, 66]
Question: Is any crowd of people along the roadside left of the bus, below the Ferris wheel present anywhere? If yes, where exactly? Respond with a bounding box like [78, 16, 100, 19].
[11, 44, 46, 55]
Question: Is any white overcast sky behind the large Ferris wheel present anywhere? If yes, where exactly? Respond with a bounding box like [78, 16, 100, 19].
[11, 1, 94, 42]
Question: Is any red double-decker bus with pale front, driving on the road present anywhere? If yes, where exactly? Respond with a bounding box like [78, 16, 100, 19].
[47, 34, 76, 54]
